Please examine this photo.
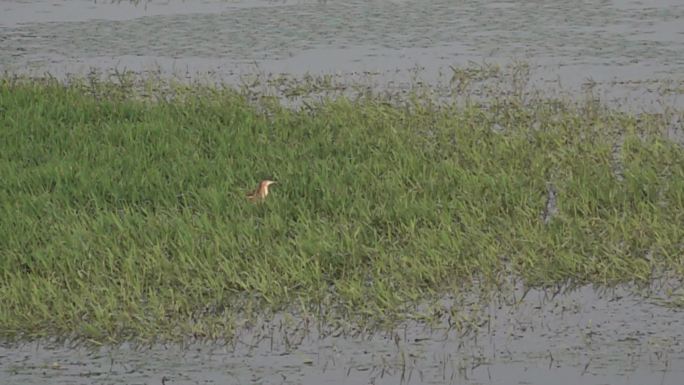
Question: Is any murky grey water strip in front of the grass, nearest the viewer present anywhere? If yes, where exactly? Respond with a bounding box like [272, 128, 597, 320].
[0, 287, 684, 385]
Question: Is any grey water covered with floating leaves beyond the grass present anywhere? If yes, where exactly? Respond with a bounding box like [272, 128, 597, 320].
[0, 0, 684, 103]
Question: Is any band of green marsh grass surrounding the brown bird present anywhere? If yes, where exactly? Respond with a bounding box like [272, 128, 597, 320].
[0, 78, 684, 343]
